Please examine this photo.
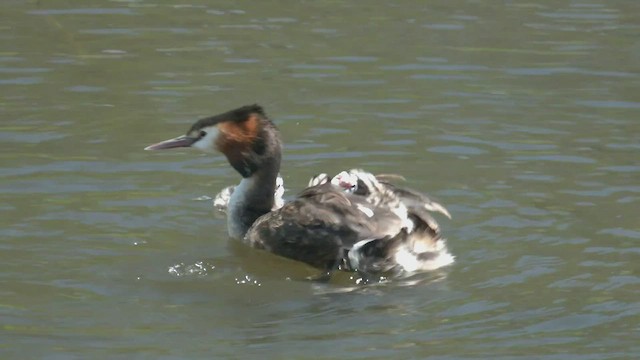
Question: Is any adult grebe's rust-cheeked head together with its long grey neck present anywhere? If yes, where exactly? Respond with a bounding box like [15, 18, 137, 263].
[145, 105, 282, 238]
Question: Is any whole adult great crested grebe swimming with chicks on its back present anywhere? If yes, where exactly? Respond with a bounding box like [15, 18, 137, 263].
[145, 105, 454, 274]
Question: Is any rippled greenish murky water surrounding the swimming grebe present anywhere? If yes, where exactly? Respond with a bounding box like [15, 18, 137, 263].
[0, 0, 640, 359]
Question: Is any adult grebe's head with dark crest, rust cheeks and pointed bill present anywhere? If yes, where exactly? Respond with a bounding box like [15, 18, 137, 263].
[145, 105, 281, 178]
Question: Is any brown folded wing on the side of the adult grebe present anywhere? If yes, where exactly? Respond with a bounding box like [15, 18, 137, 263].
[245, 184, 401, 269]
